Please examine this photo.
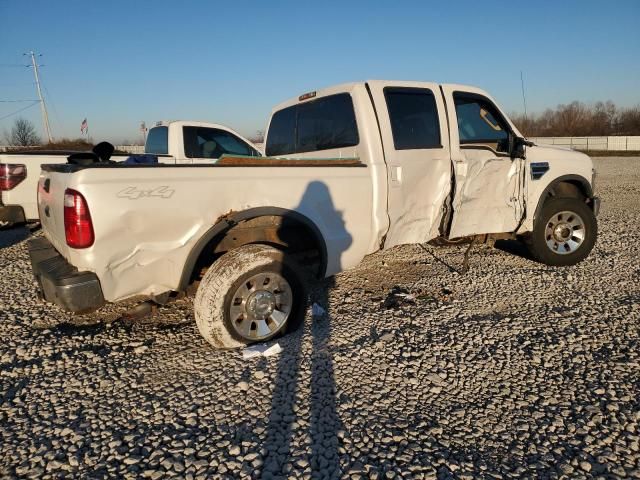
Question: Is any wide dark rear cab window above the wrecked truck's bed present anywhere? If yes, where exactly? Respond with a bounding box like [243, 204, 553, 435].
[266, 93, 360, 156]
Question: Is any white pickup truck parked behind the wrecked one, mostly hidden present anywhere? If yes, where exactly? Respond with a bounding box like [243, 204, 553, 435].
[0, 121, 261, 227]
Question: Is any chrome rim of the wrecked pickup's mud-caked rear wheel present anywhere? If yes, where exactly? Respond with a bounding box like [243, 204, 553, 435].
[229, 272, 293, 341]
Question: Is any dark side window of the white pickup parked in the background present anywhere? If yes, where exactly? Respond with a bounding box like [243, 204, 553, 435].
[182, 127, 259, 159]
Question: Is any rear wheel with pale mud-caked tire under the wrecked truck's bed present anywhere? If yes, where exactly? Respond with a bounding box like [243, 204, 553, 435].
[194, 245, 307, 348]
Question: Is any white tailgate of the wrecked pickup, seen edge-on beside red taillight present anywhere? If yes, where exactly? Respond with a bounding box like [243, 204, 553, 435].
[38, 170, 73, 258]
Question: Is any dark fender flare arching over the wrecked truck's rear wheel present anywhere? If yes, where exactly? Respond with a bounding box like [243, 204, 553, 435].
[178, 207, 328, 291]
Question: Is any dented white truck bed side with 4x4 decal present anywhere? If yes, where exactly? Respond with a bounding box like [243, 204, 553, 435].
[39, 156, 386, 302]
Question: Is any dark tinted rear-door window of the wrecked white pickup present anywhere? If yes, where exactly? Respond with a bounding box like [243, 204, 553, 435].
[384, 87, 442, 150]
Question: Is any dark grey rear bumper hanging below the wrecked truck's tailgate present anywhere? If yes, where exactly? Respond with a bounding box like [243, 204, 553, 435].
[27, 237, 105, 313]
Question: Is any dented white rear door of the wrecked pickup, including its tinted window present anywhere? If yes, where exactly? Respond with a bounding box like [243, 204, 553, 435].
[368, 81, 451, 247]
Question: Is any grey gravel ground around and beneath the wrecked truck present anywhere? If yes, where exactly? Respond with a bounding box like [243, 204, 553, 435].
[0, 158, 640, 479]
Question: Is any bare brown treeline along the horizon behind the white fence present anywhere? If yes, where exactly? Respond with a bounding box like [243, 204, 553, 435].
[510, 100, 640, 137]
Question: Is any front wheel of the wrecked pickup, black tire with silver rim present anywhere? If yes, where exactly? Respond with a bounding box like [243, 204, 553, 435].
[526, 197, 598, 267]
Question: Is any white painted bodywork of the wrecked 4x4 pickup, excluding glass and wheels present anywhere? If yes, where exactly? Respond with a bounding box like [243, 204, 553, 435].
[33, 81, 592, 301]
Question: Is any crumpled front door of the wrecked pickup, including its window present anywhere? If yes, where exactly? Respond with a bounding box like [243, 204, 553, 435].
[443, 86, 525, 238]
